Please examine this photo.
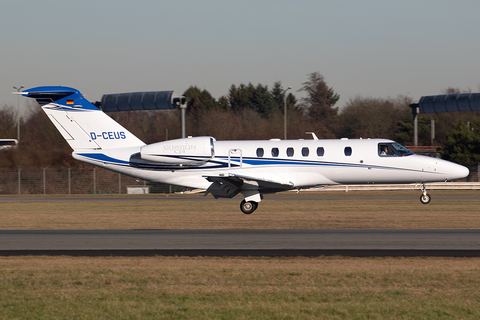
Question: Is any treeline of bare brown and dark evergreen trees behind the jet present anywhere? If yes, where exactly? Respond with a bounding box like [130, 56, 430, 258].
[0, 72, 480, 168]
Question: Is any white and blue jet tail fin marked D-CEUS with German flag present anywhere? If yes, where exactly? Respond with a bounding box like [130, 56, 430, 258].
[20, 87, 145, 151]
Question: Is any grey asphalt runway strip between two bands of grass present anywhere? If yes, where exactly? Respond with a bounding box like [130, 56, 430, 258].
[0, 229, 480, 257]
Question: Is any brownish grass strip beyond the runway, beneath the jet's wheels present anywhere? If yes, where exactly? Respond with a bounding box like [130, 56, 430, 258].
[0, 191, 480, 229]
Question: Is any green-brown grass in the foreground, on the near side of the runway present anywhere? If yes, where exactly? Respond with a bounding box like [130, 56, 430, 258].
[0, 257, 480, 319]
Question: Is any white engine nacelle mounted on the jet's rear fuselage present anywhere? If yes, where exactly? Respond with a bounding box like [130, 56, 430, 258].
[140, 137, 215, 166]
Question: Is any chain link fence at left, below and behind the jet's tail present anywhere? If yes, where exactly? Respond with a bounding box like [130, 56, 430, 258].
[0, 167, 182, 194]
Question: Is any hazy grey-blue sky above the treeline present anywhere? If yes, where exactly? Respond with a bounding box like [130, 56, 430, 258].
[0, 0, 480, 112]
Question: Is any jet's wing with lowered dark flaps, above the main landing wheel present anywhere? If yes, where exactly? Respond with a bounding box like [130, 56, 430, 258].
[204, 174, 293, 198]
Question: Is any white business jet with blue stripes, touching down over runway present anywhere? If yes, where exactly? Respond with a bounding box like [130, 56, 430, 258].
[14, 86, 469, 214]
